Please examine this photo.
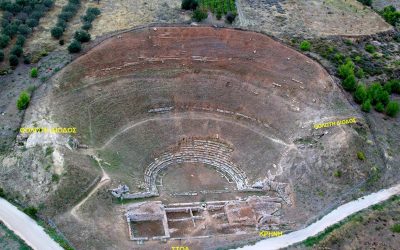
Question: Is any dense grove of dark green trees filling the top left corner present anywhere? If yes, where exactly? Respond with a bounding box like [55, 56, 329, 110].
[0, 0, 54, 66]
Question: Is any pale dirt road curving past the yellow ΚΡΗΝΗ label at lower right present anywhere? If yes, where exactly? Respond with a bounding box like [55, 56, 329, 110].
[238, 184, 400, 250]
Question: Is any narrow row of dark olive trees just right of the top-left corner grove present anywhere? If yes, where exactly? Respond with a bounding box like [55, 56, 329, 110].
[51, 0, 81, 39]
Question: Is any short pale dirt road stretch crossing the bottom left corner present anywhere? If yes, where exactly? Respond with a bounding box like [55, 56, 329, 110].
[0, 198, 63, 250]
